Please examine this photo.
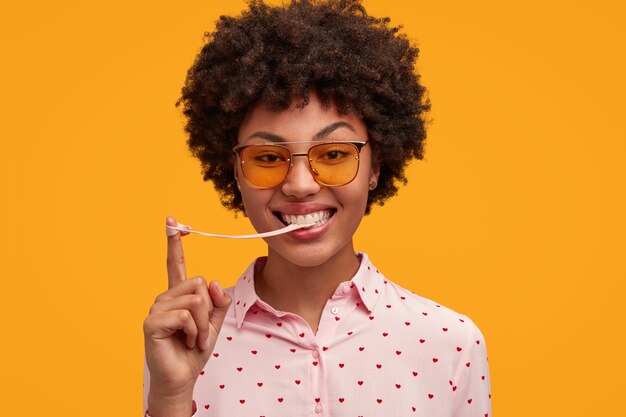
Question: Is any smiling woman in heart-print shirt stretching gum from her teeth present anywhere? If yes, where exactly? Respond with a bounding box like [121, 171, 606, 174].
[144, 0, 491, 417]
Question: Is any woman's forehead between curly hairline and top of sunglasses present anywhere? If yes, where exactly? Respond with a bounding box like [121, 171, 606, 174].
[238, 95, 367, 144]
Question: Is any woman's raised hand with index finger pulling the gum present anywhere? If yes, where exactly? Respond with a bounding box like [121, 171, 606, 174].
[143, 217, 232, 417]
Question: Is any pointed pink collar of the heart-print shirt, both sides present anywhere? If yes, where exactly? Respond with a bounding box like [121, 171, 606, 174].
[233, 252, 387, 328]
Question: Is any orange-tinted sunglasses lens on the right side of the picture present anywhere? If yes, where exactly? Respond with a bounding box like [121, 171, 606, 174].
[309, 143, 359, 186]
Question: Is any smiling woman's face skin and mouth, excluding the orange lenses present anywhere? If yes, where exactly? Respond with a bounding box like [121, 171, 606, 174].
[235, 95, 378, 266]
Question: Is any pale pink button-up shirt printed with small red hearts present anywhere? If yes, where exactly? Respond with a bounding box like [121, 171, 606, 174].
[144, 254, 491, 417]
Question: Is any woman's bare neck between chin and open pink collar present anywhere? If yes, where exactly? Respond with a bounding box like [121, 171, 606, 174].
[255, 241, 360, 332]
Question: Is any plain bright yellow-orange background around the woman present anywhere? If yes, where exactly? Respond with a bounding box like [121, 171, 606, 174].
[0, 0, 626, 417]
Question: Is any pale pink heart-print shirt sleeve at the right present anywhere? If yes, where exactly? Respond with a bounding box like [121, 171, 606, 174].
[453, 318, 491, 417]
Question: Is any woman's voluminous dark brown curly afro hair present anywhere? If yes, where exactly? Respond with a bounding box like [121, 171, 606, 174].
[176, 0, 430, 214]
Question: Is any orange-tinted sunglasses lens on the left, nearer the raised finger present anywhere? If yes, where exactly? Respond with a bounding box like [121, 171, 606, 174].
[241, 145, 289, 188]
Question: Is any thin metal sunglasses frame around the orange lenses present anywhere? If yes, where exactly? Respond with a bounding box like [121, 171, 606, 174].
[233, 140, 369, 190]
